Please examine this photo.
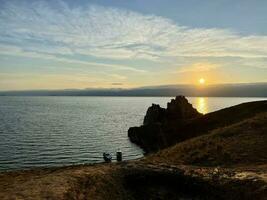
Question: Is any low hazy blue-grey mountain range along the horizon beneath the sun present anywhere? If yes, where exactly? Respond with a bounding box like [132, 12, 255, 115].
[0, 83, 267, 97]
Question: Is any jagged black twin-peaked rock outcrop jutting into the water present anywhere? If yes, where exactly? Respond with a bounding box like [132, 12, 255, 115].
[128, 96, 202, 152]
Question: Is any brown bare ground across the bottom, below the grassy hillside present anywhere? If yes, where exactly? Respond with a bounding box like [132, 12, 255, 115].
[0, 160, 267, 200]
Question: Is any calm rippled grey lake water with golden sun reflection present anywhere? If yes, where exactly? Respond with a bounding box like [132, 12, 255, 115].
[0, 97, 266, 170]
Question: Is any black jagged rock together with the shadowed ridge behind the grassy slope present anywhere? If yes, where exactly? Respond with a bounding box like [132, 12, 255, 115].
[128, 96, 267, 153]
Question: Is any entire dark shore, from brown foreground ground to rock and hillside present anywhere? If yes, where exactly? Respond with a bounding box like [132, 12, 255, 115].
[0, 96, 267, 200]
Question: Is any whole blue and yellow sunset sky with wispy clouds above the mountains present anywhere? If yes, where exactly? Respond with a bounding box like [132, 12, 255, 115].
[0, 0, 267, 90]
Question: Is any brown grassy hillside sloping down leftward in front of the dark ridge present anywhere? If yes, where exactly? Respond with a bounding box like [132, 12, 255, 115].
[147, 112, 267, 166]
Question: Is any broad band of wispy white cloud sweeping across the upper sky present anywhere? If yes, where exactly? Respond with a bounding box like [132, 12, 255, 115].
[0, 1, 267, 59]
